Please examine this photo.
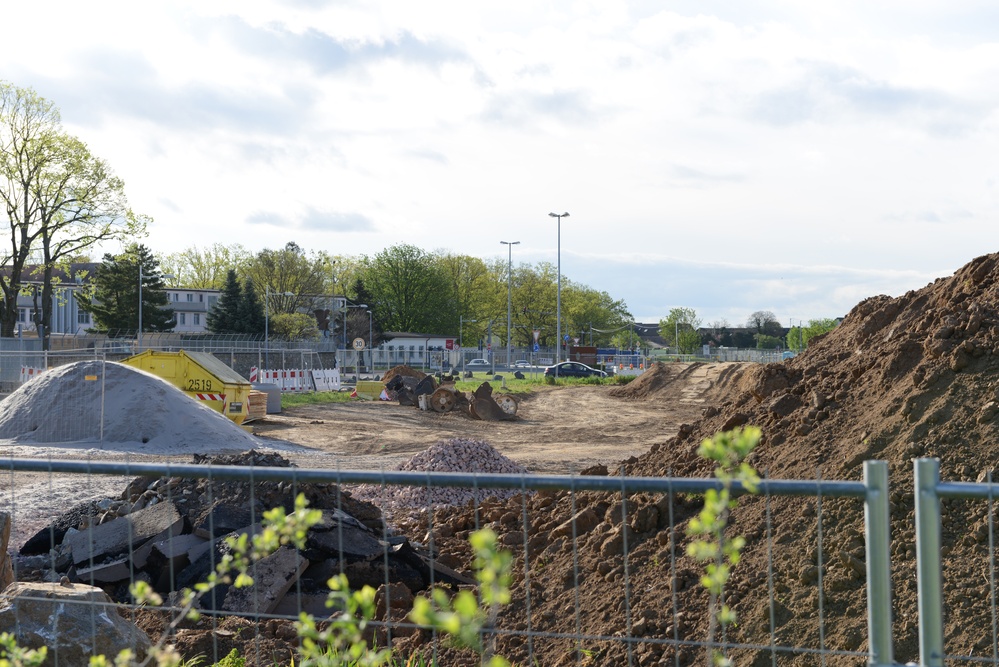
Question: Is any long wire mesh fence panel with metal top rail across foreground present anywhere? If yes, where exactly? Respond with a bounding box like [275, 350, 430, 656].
[0, 460, 892, 666]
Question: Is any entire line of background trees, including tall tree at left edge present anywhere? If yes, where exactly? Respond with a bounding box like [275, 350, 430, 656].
[0, 81, 840, 351]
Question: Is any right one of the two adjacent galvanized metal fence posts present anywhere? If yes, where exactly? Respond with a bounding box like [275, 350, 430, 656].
[913, 459, 944, 667]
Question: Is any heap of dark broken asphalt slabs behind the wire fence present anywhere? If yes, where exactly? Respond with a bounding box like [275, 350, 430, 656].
[14, 451, 472, 616]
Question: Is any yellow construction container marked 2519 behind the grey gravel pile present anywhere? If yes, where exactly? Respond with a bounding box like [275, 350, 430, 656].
[122, 350, 251, 424]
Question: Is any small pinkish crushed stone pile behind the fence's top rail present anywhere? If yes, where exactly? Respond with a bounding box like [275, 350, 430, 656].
[351, 438, 528, 513]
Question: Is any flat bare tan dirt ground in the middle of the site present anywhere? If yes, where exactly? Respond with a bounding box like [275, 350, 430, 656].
[253, 364, 739, 474]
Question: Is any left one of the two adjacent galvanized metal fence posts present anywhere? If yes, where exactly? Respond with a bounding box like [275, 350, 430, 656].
[864, 461, 894, 667]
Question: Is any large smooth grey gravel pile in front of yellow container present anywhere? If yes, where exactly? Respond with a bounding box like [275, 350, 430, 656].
[0, 360, 278, 454]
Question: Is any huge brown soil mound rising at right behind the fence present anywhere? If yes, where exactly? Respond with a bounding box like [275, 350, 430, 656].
[414, 255, 999, 665]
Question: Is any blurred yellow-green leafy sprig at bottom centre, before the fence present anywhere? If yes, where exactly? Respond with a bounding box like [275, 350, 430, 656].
[410, 528, 513, 667]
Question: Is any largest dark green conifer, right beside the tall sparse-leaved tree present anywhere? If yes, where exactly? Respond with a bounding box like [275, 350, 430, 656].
[80, 244, 175, 332]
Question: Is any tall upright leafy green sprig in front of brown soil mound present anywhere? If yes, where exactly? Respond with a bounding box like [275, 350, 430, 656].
[687, 426, 761, 666]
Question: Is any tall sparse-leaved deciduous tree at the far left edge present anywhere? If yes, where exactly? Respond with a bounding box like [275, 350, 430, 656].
[0, 82, 147, 348]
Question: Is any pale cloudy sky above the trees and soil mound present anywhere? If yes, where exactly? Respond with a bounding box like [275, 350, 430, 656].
[0, 0, 999, 326]
